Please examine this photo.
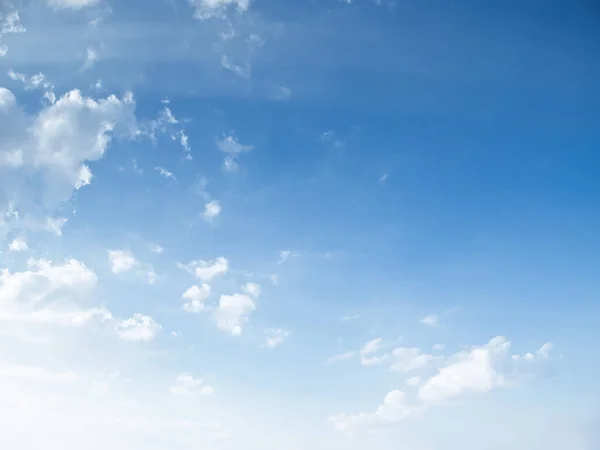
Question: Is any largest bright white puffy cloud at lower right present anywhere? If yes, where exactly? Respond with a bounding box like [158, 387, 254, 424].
[419, 336, 510, 403]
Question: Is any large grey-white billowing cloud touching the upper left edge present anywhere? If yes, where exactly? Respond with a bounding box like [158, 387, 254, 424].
[0, 89, 137, 221]
